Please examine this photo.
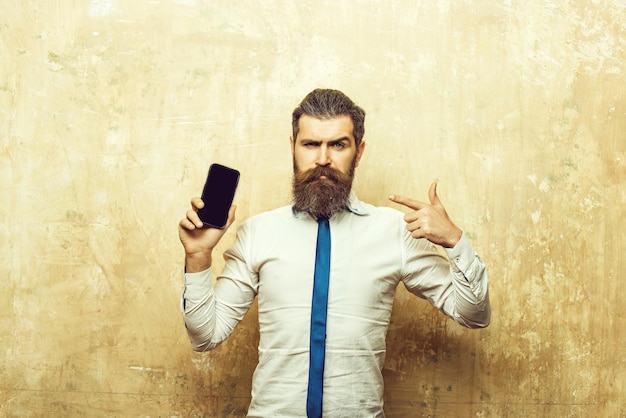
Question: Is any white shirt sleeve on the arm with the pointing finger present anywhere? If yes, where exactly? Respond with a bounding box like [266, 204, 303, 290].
[403, 233, 491, 328]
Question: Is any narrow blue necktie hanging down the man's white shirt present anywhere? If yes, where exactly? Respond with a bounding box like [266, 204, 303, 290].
[306, 219, 330, 418]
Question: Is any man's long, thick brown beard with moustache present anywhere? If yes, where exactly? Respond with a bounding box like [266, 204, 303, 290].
[293, 161, 355, 219]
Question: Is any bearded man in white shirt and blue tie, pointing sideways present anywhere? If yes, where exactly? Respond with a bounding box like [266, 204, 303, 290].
[179, 89, 491, 418]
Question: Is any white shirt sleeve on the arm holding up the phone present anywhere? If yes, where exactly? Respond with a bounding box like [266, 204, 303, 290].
[181, 224, 258, 351]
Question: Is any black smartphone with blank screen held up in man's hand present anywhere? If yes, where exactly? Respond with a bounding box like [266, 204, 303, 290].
[198, 164, 239, 229]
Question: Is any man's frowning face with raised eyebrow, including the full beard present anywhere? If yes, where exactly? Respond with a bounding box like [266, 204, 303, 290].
[291, 115, 365, 218]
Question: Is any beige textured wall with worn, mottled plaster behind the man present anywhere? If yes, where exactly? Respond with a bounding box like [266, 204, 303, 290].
[0, 0, 626, 417]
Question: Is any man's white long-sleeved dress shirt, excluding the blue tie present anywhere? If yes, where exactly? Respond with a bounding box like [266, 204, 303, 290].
[182, 194, 490, 418]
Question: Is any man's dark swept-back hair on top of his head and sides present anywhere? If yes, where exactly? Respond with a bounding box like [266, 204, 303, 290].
[291, 89, 365, 147]
